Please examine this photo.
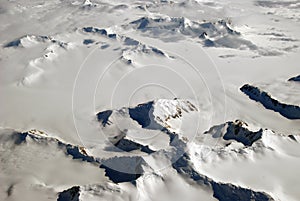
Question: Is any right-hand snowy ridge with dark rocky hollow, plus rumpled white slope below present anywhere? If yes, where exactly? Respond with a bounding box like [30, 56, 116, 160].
[195, 120, 299, 164]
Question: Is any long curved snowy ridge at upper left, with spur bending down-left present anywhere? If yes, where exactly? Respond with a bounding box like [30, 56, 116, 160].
[3, 27, 172, 86]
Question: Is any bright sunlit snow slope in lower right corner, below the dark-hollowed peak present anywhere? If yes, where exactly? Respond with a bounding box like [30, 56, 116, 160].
[189, 123, 300, 200]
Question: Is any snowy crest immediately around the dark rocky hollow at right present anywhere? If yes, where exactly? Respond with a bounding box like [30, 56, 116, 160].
[197, 120, 299, 152]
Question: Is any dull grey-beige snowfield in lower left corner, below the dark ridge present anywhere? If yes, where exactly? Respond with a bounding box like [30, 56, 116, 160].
[0, 130, 107, 200]
